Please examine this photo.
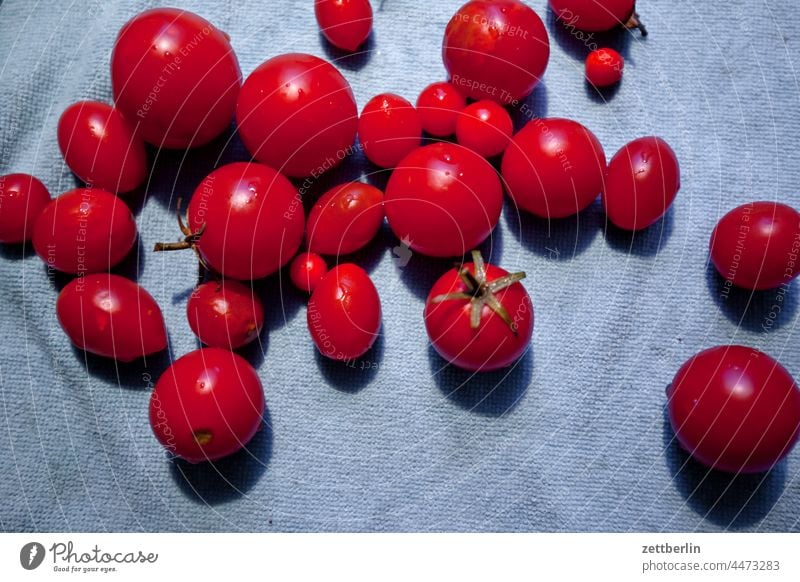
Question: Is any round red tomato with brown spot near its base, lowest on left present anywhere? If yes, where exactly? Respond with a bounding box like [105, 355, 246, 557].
[150, 348, 264, 463]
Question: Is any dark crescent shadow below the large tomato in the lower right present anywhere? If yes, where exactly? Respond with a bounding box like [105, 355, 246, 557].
[663, 407, 786, 530]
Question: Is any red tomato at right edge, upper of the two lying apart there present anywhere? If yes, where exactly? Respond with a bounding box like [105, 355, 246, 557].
[710, 202, 800, 290]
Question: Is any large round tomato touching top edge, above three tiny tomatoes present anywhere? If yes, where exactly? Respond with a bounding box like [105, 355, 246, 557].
[442, 0, 550, 104]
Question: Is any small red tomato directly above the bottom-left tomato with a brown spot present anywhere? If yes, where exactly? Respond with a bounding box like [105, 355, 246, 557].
[186, 281, 264, 350]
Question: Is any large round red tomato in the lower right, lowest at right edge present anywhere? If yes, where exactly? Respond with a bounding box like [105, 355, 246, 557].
[667, 346, 800, 473]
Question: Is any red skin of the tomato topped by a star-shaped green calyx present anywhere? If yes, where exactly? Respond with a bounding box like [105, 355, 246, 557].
[425, 263, 534, 372]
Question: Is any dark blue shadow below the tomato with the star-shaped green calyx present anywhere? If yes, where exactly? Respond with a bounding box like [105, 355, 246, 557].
[428, 345, 534, 417]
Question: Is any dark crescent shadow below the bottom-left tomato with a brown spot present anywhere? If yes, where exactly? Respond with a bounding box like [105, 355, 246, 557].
[170, 409, 273, 505]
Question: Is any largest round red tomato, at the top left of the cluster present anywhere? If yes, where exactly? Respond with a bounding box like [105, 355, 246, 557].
[111, 8, 242, 148]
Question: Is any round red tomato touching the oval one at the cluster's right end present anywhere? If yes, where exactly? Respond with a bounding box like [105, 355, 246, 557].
[502, 118, 606, 218]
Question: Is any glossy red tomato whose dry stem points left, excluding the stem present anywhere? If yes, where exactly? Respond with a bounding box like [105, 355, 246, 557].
[188, 162, 305, 281]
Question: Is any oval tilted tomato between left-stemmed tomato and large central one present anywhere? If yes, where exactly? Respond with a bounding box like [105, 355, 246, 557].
[306, 182, 383, 255]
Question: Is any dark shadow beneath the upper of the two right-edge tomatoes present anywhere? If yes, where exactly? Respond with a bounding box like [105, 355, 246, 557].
[706, 261, 797, 333]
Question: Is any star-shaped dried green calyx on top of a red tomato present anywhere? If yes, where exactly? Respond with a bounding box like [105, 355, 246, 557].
[432, 250, 526, 335]
